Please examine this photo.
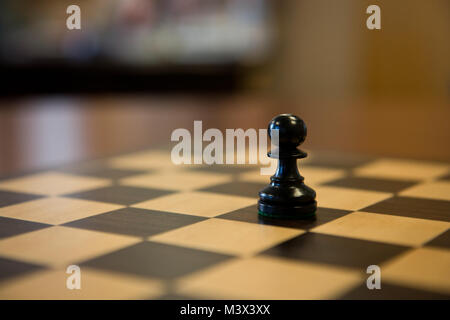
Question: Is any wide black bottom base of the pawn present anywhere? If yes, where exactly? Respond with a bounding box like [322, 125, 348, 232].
[258, 200, 317, 220]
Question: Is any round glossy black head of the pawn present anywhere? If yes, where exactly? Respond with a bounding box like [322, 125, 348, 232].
[267, 114, 306, 147]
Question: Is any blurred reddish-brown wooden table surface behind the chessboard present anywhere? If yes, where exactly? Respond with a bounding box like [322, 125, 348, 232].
[0, 95, 450, 175]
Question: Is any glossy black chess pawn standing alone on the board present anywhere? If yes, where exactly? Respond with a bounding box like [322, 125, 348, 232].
[258, 114, 317, 219]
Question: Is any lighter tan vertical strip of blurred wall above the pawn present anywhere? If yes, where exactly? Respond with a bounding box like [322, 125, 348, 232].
[275, 0, 362, 98]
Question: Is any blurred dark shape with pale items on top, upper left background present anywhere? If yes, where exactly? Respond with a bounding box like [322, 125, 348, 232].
[0, 0, 272, 94]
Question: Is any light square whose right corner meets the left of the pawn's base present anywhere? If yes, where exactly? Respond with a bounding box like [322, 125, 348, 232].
[133, 192, 256, 217]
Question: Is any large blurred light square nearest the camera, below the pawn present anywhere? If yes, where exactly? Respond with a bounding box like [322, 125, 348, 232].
[177, 256, 364, 300]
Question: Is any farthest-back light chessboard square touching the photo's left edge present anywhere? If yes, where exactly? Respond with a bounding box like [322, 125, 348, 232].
[0, 172, 111, 196]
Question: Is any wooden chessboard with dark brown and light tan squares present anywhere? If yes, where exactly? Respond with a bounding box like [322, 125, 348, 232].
[0, 149, 450, 299]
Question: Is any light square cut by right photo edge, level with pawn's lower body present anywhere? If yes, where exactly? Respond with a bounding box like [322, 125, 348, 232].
[400, 181, 450, 201]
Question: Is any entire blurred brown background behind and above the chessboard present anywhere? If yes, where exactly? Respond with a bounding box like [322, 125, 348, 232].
[0, 0, 450, 175]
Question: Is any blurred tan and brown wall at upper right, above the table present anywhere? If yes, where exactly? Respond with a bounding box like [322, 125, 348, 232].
[276, 0, 450, 99]
